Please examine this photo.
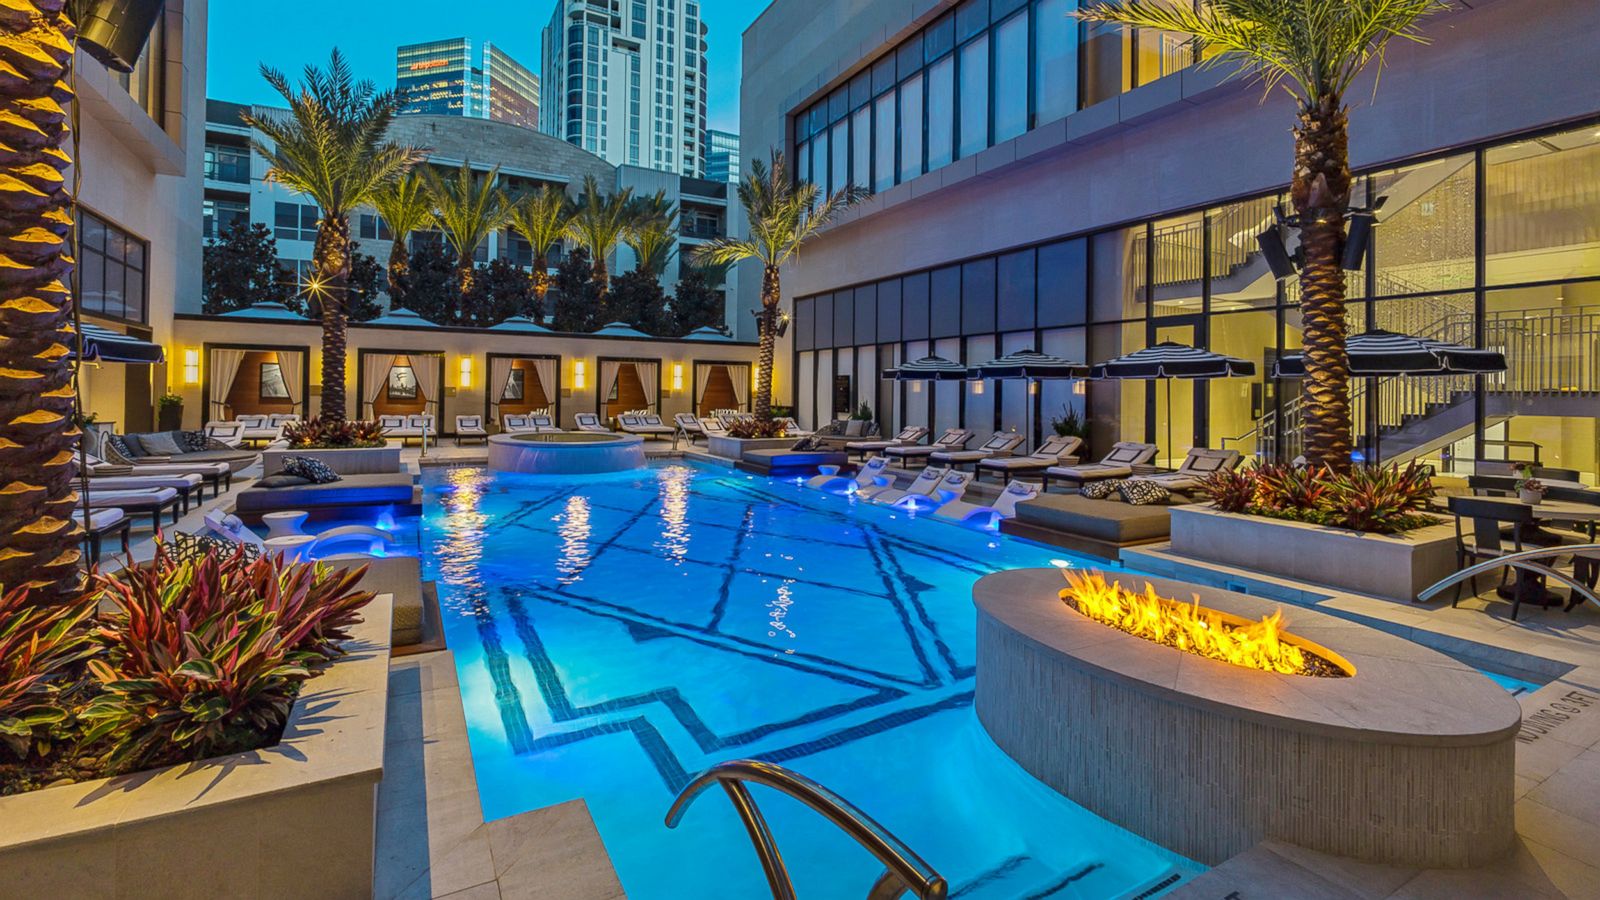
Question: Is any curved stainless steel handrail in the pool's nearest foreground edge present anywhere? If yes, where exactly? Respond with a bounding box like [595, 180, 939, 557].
[667, 759, 949, 900]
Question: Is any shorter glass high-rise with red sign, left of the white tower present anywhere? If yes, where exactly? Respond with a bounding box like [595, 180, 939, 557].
[395, 37, 539, 128]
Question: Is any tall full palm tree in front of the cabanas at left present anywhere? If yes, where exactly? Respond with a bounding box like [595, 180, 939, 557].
[242, 50, 426, 421]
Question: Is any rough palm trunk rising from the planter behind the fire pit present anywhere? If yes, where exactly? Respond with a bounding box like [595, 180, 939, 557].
[1290, 96, 1352, 471]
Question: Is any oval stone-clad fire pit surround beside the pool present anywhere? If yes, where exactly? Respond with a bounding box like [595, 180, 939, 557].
[973, 569, 1522, 866]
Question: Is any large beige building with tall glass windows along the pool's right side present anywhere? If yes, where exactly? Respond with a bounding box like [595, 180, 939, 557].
[741, 0, 1600, 476]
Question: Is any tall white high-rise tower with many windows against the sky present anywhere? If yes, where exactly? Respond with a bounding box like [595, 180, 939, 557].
[541, 0, 706, 178]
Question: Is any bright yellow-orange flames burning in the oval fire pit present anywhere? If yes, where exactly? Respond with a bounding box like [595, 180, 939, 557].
[1061, 570, 1354, 677]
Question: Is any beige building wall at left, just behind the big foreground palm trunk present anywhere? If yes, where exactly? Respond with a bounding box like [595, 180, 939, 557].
[75, 0, 206, 431]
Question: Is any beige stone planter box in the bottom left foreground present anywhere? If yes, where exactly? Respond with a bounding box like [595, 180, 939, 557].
[0, 594, 392, 898]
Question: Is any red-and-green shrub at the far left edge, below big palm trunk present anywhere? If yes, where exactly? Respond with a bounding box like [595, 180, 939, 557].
[0, 588, 94, 759]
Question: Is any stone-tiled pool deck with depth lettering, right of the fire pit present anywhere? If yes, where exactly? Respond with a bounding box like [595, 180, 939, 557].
[1123, 544, 1600, 900]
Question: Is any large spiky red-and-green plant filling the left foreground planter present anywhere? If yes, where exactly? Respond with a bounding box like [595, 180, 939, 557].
[80, 544, 373, 773]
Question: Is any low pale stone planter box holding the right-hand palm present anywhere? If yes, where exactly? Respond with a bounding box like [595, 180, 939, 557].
[1173, 504, 1456, 602]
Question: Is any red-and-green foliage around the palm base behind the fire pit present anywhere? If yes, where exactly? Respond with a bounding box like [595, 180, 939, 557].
[1202, 463, 1437, 535]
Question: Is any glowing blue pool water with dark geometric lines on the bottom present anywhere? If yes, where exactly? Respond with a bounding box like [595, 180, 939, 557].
[421, 464, 1200, 900]
